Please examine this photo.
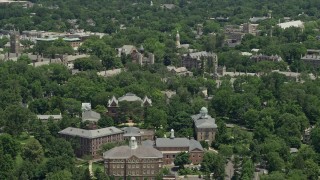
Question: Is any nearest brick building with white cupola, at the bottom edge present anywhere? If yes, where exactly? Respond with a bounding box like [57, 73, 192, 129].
[103, 137, 163, 180]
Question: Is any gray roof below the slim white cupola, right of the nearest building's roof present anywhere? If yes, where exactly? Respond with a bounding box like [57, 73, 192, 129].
[156, 138, 203, 151]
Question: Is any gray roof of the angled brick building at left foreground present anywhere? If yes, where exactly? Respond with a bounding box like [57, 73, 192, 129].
[59, 126, 123, 139]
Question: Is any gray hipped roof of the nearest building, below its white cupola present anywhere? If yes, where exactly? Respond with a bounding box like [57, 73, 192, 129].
[103, 146, 163, 159]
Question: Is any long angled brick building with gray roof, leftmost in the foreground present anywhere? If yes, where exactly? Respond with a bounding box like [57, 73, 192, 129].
[59, 127, 123, 158]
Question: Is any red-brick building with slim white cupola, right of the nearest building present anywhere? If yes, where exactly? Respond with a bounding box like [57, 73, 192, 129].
[154, 129, 204, 164]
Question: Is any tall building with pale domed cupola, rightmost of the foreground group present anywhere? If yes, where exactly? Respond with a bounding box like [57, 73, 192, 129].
[191, 107, 218, 145]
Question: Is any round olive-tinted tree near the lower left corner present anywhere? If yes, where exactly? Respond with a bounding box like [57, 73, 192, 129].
[21, 139, 44, 163]
